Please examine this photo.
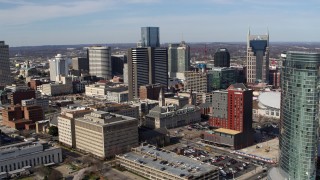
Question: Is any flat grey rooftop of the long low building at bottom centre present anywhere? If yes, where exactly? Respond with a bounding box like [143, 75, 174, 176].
[121, 145, 218, 177]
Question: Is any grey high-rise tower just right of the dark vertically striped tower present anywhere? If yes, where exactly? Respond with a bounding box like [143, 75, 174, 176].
[168, 41, 190, 77]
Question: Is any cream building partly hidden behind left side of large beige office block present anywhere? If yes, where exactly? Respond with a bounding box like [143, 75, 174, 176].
[58, 109, 92, 148]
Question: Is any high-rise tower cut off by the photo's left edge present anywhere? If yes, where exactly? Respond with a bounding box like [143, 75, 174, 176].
[0, 41, 12, 87]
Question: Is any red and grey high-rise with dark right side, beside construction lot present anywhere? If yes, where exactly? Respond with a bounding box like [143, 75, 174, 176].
[205, 83, 253, 149]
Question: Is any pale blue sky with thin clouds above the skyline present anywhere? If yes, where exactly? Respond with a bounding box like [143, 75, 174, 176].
[0, 0, 320, 46]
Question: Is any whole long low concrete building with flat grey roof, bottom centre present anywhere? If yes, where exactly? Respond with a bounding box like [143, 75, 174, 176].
[116, 145, 219, 180]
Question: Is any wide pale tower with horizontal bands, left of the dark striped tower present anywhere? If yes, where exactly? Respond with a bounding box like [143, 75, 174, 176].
[88, 46, 112, 79]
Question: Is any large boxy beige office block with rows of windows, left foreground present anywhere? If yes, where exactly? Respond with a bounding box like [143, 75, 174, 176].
[75, 111, 138, 159]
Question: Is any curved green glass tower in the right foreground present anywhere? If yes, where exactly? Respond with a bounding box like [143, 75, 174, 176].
[268, 51, 320, 180]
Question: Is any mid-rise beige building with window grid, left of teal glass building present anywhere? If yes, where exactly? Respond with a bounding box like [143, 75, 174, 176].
[184, 71, 208, 92]
